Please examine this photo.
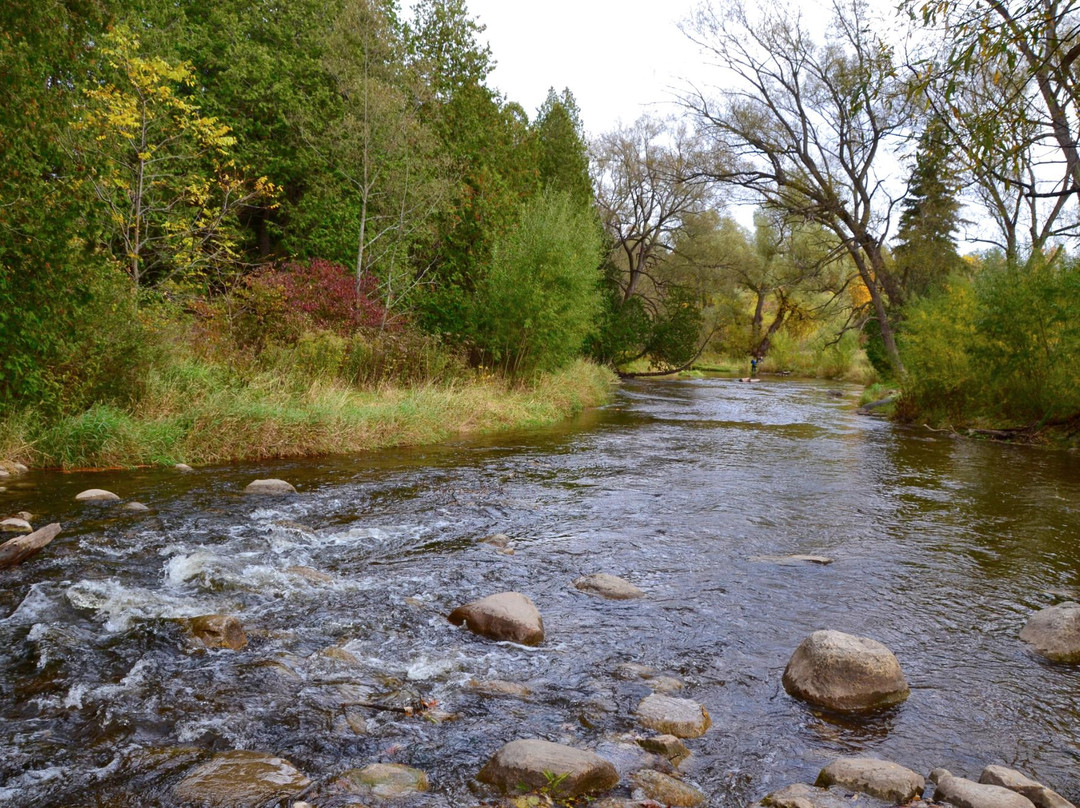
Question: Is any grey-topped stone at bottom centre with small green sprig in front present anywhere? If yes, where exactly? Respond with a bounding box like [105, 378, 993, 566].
[476, 740, 619, 797]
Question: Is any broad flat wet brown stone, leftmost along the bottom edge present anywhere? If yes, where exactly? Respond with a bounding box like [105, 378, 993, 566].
[173, 750, 311, 808]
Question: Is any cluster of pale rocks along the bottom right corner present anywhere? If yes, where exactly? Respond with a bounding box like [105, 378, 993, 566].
[755, 757, 1074, 808]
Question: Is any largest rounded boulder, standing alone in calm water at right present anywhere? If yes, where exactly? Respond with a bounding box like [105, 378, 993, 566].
[783, 631, 910, 712]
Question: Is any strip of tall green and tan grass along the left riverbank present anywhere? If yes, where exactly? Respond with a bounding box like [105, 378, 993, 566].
[0, 361, 616, 469]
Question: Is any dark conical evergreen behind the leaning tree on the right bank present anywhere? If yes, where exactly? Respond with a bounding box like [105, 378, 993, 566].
[894, 119, 961, 300]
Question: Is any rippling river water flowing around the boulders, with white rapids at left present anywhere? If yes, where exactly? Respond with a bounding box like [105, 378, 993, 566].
[0, 378, 1080, 808]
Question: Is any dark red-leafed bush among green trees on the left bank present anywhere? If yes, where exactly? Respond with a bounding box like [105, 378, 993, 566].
[248, 258, 386, 334]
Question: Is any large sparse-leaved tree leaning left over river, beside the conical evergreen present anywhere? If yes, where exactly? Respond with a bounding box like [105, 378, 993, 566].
[686, 0, 910, 373]
